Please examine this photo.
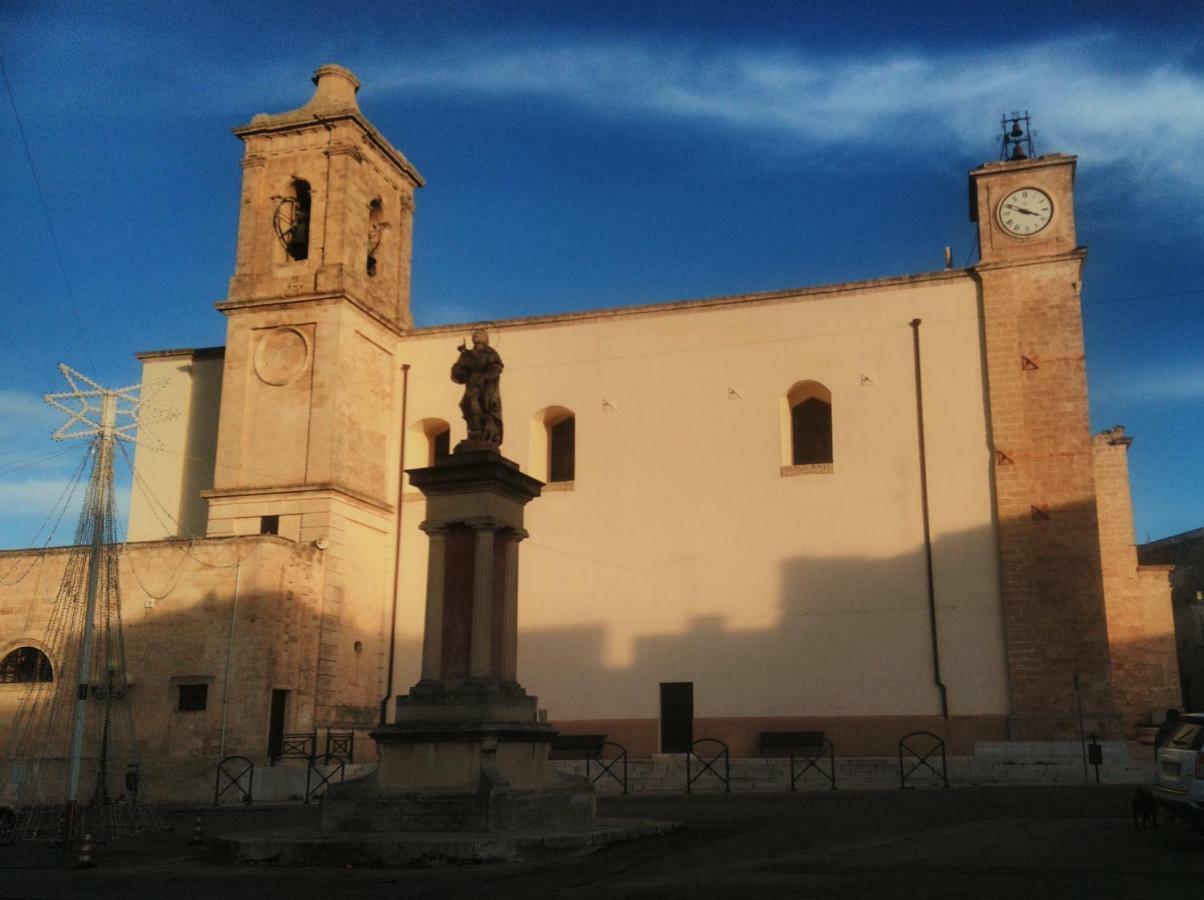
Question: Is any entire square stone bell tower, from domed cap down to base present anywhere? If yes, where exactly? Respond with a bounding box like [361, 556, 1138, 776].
[205, 65, 423, 728]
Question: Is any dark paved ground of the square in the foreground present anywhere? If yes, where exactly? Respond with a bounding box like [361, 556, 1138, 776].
[0, 787, 1204, 900]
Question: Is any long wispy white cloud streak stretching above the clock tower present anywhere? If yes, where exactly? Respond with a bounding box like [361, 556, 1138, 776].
[365, 34, 1204, 191]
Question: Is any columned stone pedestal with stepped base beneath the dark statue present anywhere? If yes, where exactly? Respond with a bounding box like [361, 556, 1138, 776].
[321, 445, 595, 831]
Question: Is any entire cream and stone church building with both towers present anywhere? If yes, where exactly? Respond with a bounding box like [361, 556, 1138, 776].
[0, 65, 1180, 771]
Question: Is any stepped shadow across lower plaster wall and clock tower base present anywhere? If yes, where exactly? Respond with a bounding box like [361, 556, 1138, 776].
[519, 505, 1155, 756]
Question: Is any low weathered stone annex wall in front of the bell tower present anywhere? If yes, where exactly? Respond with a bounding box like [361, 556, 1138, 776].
[0, 535, 329, 762]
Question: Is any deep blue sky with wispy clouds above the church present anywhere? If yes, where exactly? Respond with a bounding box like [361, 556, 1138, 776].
[0, 0, 1204, 546]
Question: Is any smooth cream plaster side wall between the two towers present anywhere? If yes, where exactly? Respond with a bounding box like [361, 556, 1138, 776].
[396, 277, 1008, 720]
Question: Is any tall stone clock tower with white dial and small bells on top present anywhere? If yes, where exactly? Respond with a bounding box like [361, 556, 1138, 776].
[969, 128, 1119, 740]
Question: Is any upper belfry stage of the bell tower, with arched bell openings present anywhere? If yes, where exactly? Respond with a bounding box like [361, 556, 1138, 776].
[229, 65, 423, 328]
